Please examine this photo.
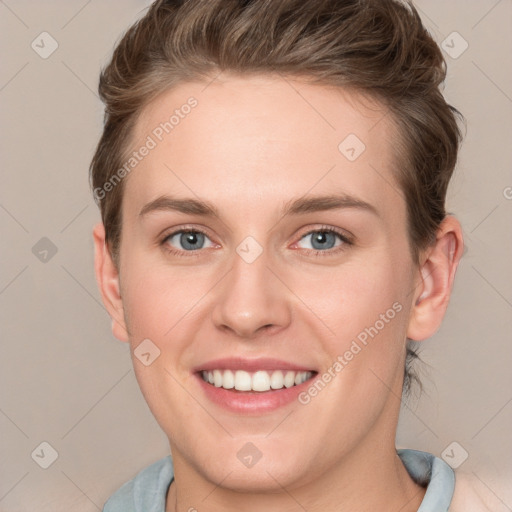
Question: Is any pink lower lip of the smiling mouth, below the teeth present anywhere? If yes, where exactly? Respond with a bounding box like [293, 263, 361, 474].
[195, 373, 317, 414]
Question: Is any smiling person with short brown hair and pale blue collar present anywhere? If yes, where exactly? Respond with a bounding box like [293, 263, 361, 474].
[91, 0, 492, 512]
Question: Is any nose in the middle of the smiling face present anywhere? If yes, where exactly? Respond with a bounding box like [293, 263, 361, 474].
[212, 245, 292, 339]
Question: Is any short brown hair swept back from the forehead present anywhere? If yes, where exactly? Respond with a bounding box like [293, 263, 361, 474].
[90, 0, 462, 396]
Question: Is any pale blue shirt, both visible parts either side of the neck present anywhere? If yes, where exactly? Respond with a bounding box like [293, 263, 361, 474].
[103, 449, 455, 512]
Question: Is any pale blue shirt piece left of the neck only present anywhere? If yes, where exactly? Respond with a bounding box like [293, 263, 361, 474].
[103, 455, 174, 512]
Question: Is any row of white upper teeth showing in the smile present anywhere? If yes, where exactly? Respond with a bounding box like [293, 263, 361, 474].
[201, 370, 313, 391]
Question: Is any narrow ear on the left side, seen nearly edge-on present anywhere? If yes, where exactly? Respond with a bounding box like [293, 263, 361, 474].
[93, 222, 129, 341]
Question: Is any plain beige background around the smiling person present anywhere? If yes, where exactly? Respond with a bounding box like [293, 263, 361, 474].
[0, 0, 512, 512]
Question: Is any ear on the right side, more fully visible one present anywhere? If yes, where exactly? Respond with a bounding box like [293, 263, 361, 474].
[407, 216, 464, 341]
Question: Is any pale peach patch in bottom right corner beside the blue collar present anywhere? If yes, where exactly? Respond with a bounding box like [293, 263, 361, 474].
[450, 472, 510, 512]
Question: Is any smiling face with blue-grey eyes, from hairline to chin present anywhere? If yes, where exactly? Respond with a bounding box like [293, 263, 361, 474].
[107, 76, 424, 490]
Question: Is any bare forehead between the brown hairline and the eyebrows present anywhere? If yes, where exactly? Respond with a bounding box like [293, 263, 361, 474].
[125, 75, 398, 219]
